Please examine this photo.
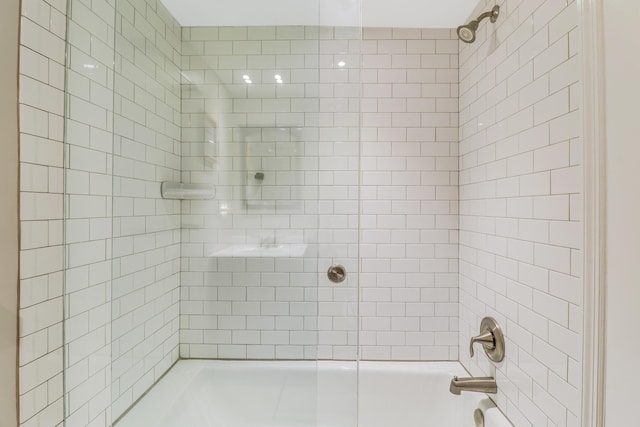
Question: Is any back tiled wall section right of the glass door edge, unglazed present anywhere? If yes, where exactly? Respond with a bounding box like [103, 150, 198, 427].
[360, 28, 458, 360]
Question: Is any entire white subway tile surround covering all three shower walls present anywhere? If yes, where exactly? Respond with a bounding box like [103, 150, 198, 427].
[20, 0, 582, 427]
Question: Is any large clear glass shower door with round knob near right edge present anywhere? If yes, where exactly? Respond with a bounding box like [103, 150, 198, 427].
[65, 0, 361, 427]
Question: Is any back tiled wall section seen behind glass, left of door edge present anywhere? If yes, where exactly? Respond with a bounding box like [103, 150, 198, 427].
[181, 26, 360, 359]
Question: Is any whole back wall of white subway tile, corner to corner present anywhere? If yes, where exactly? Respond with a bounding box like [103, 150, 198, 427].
[181, 27, 458, 360]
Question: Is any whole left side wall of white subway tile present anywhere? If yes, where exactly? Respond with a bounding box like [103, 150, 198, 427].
[20, 0, 180, 426]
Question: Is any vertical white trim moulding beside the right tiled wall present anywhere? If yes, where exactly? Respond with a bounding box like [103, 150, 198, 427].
[577, 0, 606, 427]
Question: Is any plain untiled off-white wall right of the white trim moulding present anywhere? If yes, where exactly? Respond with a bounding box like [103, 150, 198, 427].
[602, 1, 640, 426]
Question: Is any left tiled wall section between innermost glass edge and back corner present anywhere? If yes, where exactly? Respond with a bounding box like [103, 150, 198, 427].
[110, 0, 182, 420]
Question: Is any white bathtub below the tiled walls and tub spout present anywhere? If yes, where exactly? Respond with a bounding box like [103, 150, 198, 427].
[116, 360, 511, 427]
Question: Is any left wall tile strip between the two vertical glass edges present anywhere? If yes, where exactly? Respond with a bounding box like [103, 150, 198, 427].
[64, 1, 114, 427]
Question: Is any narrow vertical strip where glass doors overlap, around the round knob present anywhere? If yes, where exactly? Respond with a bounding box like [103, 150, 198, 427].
[318, 0, 362, 427]
